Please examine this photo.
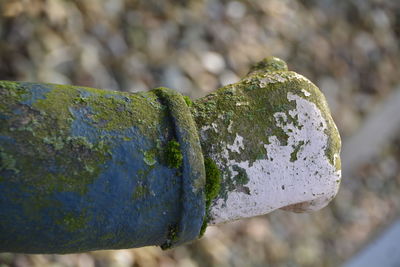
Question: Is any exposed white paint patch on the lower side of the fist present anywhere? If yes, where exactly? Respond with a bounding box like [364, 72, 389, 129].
[210, 93, 341, 224]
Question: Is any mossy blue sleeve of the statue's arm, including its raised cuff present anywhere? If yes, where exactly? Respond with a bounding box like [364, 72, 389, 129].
[0, 82, 205, 253]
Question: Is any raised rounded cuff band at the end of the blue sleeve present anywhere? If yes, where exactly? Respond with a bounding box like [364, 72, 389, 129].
[153, 87, 206, 249]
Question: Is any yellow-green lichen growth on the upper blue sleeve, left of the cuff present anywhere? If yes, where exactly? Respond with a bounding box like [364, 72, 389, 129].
[0, 82, 169, 224]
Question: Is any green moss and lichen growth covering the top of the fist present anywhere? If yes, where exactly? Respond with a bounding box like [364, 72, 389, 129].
[191, 58, 340, 205]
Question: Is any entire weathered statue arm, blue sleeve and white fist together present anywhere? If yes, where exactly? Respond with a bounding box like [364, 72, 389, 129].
[0, 58, 340, 253]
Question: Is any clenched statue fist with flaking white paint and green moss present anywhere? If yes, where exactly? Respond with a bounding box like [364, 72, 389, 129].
[193, 58, 341, 224]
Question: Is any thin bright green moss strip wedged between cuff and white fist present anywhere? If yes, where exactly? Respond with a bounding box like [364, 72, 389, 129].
[199, 158, 221, 237]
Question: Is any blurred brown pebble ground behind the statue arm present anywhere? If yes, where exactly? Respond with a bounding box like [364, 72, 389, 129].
[0, 0, 400, 267]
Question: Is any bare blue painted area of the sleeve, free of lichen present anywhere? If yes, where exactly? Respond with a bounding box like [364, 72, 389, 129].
[0, 83, 205, 253]
